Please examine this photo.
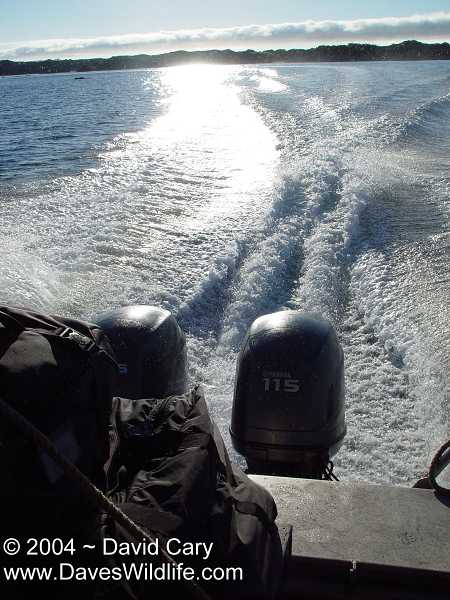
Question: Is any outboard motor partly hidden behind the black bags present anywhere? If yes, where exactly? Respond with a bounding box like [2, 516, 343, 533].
[94, 305, 187, 399]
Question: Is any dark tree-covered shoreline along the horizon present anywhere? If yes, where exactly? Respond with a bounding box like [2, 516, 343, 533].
[0, 40, 450, 75]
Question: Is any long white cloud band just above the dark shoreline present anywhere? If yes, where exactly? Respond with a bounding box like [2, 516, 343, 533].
[0, 12, 450, 60]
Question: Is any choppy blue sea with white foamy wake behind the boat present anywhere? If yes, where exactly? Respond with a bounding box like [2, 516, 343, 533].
[0, 61, 450, 485]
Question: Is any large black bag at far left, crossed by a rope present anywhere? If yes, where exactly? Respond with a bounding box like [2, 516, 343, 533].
[0, 306, 117, 600]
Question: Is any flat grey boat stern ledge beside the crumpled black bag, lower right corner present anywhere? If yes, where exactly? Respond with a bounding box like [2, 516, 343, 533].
[252, 475, 450, 600]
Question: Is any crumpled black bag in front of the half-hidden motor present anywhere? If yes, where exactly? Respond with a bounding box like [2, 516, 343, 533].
[108, 387, 282, 599]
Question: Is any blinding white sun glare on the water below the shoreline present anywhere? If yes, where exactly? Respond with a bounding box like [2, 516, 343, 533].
[138, 65, 277, 229]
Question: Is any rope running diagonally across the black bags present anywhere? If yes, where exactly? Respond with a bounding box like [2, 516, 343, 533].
[0, 398, 211, 600]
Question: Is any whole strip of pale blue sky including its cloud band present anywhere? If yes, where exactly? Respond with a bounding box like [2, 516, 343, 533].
[0, 0, 450, 60]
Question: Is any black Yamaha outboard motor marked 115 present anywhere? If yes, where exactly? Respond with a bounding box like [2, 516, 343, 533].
[230, 311, 346, 479]
